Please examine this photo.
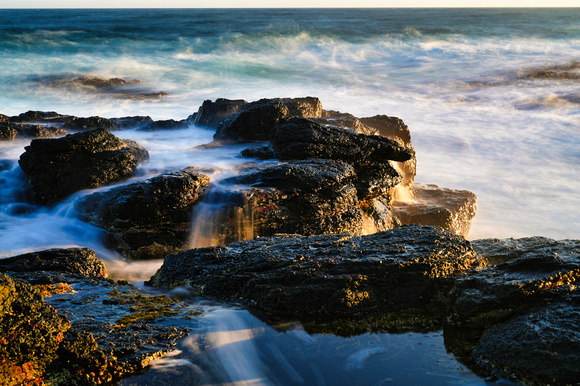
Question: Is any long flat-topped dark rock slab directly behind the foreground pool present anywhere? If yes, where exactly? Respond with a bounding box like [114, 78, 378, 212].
[147, 226, 479, 330]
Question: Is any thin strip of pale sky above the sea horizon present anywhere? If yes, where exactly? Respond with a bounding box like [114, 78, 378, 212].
[0, 0, 580, 8]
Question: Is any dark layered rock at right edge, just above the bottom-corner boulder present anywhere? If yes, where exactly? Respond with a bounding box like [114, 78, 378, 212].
[448, 237, 580, 329]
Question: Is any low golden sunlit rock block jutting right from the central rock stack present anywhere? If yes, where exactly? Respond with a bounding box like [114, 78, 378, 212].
[393, 184, 477, 236]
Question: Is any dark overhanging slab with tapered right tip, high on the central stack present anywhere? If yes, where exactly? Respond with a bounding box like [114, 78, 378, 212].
[271, 118, 414, 164]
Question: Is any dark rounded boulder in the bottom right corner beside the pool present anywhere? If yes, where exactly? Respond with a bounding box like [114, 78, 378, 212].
[473, 288, 580, 385]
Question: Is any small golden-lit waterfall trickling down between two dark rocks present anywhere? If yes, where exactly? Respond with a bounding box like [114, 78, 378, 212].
[189, 182, 254, 248]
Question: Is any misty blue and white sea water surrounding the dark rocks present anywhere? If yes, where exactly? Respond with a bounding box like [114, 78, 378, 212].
[0, 8, 580, 384]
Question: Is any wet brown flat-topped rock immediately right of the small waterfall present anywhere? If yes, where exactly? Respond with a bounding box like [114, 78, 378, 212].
[224, 159, 363, 237]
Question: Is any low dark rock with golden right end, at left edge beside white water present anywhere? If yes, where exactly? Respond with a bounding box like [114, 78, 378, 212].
[0, 248, 105, 277]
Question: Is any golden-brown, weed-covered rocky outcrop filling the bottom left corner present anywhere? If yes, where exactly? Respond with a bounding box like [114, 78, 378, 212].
[0, 248, 198, 386]
